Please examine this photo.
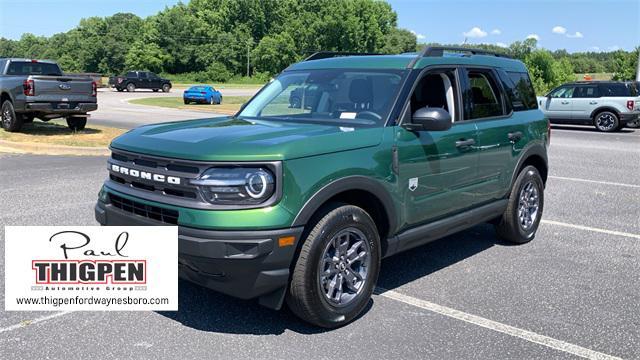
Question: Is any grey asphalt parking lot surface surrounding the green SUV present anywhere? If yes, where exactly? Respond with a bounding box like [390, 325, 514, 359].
[0, 117, 640, 359]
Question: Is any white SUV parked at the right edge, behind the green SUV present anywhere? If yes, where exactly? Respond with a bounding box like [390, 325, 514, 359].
[538, 81, 640, 132]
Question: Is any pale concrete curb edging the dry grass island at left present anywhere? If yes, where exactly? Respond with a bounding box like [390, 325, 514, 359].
[0, 140, 111, 156]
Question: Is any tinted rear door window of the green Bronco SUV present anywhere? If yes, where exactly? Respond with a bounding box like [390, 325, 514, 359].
[469, 70, 504, 119]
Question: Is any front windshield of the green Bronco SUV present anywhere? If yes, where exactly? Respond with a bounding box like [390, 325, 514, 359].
[238, 69, 405, 126]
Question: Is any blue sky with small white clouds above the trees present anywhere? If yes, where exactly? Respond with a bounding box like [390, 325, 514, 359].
[0, 0, 640, 52]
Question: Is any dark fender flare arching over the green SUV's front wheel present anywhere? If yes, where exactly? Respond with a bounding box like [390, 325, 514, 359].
[291, 175, 397, 236]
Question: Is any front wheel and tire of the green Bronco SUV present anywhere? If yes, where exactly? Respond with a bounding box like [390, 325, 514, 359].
[287, 204, 380, 328]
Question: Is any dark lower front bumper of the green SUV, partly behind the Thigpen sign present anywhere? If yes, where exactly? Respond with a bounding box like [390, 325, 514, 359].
[95, 201, 303, 309]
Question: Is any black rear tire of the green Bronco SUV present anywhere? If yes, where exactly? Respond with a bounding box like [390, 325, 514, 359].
[495, 166, 544, 244]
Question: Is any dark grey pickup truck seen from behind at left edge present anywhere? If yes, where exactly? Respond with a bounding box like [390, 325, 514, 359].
[0, 59, 98, 132]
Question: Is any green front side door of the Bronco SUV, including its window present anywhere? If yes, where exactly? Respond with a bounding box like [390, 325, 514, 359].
[395, 69, 478, 227]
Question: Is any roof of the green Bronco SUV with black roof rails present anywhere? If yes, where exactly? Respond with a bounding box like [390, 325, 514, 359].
[287, 53, 526, 72]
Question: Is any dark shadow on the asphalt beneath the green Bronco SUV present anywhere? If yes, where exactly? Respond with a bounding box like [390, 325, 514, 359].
[158, 225, 509, 335]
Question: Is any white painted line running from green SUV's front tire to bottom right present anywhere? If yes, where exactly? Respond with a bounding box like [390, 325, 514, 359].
[375, 287, 620, 360]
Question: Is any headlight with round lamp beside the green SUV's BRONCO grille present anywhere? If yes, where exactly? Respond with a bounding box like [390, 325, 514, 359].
[191, 167, 276, 205]
